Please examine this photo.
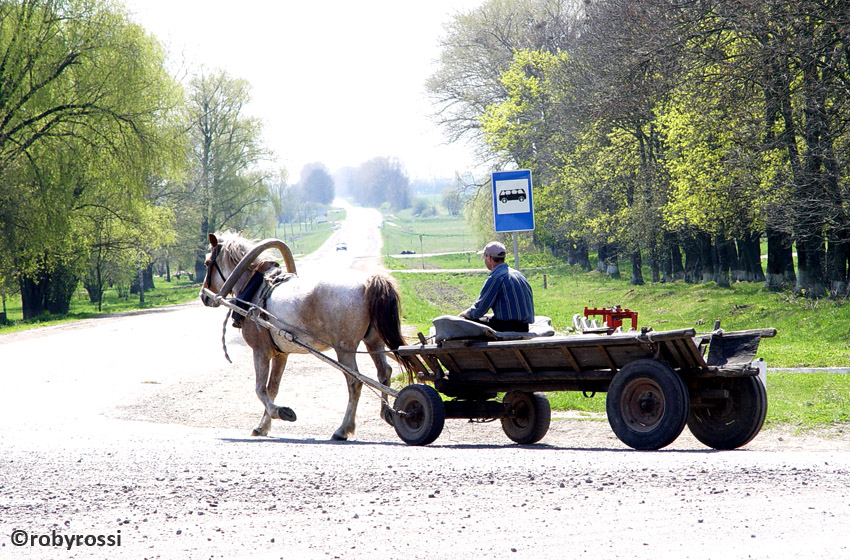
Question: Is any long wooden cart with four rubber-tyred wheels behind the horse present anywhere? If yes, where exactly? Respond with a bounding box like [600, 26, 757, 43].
[394, 328, 776, 449]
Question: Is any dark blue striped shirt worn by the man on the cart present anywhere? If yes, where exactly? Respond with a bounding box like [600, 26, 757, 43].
[464, 263, 534, 323]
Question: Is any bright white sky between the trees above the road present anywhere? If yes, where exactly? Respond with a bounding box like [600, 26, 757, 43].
[125, 0, 484, 182]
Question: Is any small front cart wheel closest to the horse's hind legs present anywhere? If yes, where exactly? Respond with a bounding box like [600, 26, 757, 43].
[394, 383, 446, 445]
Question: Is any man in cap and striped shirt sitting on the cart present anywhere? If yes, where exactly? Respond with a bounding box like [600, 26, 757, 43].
[460, 241, 534, 332]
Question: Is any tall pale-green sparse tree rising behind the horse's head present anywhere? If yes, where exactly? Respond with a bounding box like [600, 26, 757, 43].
[189, 70, 271, 278]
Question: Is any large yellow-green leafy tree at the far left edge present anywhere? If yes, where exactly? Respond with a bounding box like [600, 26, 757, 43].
[0, 0, 185, 318]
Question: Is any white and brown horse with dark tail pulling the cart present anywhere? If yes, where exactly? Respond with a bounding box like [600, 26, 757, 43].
[200, 231, 408, 441]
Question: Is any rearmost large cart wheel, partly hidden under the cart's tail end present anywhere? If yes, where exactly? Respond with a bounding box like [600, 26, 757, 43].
[688, 377, 767, 449]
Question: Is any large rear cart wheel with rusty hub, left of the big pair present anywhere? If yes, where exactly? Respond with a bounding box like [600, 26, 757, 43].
[605, 360, 689, 450]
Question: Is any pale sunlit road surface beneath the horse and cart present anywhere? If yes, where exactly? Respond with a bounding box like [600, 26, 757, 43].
[0, 209, 850, 560]
